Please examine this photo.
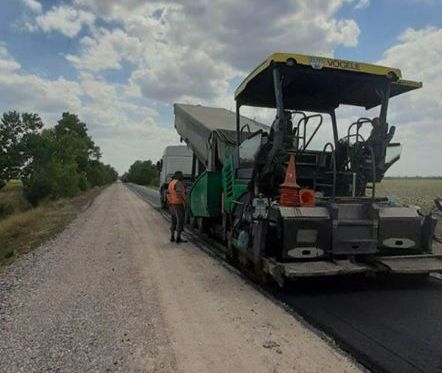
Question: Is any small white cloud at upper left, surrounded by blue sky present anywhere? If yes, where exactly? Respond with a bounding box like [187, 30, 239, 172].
[35, 5, 95, 38]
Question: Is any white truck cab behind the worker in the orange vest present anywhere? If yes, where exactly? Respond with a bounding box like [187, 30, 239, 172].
[160, 145, 193, 208]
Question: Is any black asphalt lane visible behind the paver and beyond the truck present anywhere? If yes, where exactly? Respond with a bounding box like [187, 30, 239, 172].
[128, 184, 442, 373]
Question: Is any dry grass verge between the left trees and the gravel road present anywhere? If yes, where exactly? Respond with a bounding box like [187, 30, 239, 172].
[0, 188, 103, 266]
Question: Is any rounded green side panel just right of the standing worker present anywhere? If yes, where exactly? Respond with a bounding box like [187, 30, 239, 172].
[189, 171, 222, 218]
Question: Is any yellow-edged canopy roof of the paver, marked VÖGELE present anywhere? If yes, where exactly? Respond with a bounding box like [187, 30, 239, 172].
[235, 53, 422, 112]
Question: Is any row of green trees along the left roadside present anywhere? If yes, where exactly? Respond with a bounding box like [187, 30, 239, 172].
[0, 111, 118, 205]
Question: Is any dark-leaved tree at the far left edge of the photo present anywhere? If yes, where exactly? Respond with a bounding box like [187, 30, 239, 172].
[0, 111, 43, 181]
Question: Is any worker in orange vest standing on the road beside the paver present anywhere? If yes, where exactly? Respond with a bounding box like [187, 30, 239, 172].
[167, 171, 186, 243]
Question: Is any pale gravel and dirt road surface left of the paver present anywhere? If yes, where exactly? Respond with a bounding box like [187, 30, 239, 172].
[0, 184, 359, 373]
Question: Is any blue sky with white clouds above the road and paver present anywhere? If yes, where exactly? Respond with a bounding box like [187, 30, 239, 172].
[0, 0, 442, 176]
